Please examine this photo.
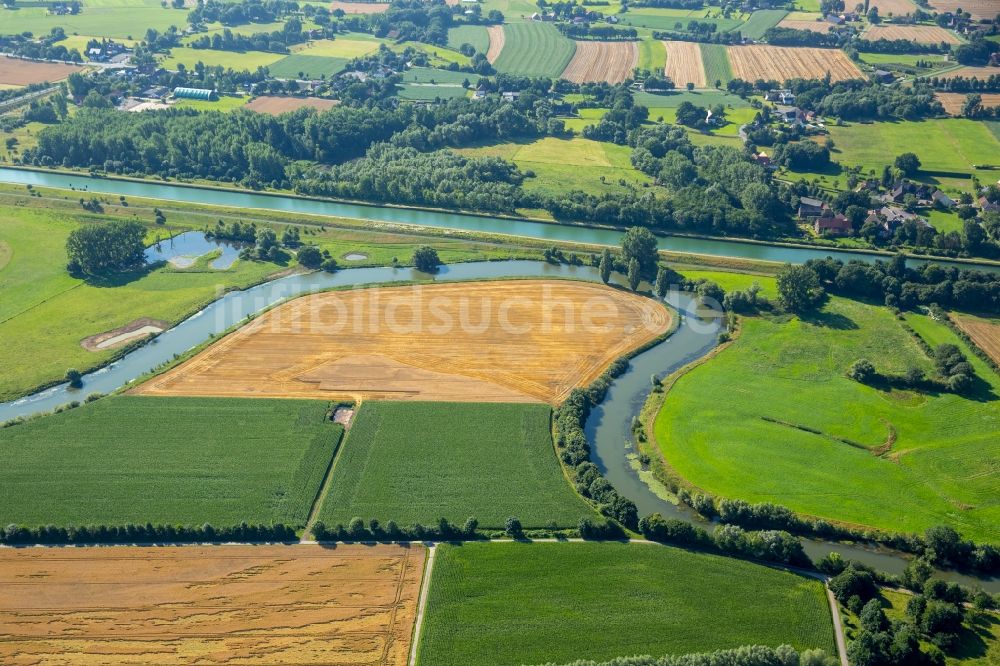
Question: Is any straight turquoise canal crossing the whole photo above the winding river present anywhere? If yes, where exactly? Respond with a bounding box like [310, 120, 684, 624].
[0, 167, 1000, 272]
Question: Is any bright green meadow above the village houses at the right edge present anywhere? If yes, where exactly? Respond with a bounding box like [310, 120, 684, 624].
[829, 118, 1000, 187]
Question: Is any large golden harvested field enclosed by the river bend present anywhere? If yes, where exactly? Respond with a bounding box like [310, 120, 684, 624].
[134, 280, 670, 404]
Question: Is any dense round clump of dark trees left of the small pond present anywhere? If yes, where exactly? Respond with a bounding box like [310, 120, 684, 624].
[66, 220, 146, 276]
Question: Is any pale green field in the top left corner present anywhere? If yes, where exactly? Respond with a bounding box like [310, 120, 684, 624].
[0, 0, 187, 39]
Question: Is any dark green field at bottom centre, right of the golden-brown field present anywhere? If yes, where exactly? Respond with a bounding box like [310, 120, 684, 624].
[418, 543, 833, 666]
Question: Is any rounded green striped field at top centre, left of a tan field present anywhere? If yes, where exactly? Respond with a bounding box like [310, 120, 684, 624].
[490, 21, 576, 79]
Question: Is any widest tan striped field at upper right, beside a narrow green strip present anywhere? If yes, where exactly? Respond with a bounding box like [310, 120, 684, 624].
[726, 44, 864, 82]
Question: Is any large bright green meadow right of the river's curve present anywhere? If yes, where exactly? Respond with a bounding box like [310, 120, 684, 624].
[655, 298, 1000, 542]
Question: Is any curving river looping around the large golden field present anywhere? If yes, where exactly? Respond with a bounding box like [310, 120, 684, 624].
[0, 254, 1000, 591]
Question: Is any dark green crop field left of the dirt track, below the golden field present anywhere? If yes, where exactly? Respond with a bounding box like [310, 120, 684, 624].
[0, 396, 342, 526]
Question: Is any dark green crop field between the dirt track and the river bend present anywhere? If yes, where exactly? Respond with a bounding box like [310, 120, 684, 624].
[320, 402, 593, 528]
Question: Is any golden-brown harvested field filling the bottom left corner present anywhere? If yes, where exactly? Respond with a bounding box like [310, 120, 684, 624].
[0, 545, 426, 666]
